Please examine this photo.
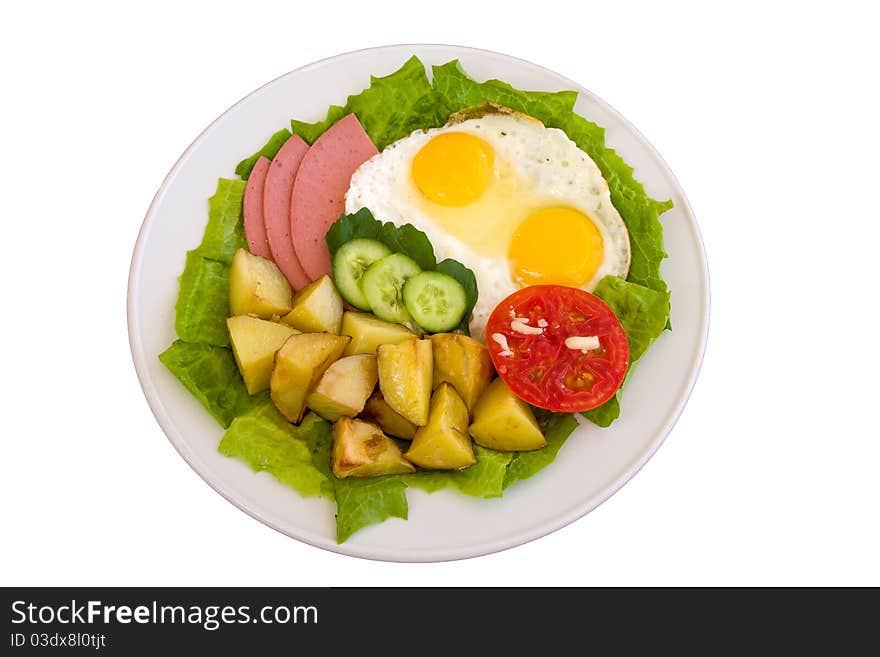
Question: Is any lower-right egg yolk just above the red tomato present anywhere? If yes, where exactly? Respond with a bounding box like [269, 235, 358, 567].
[509, 207, 602, 287]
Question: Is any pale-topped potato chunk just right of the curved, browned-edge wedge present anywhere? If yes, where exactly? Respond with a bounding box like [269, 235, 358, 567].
[306, 354, 379, 422]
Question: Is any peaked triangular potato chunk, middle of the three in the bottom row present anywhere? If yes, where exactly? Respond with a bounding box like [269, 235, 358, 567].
[404, 383, 477, 470]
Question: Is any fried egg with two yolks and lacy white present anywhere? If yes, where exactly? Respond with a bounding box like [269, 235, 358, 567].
[345, 112, 630, 338]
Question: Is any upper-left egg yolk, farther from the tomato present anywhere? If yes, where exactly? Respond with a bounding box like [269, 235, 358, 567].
[412, 132, 494, 205]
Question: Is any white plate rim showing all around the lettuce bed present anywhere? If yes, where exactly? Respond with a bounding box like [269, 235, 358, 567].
[126, 43, 712, 563]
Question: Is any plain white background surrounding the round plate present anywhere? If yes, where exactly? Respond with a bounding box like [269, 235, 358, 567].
[0, 0, 880, 586]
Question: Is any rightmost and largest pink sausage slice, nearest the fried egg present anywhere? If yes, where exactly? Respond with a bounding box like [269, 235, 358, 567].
[290, 114, 379, 279]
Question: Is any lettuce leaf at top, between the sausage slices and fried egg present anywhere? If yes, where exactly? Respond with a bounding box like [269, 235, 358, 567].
[291, 57, 441, 151]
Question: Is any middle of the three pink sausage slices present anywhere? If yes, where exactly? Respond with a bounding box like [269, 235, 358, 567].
[262, 135, 311, 290]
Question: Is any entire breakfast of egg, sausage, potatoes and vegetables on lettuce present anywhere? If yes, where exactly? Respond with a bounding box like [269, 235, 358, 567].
[160, 53, 669, 542]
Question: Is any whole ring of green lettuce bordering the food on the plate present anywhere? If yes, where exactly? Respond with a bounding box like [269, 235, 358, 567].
[159, 57, 672, 543]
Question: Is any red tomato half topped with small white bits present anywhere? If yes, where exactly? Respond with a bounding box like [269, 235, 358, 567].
[486, 285, 629, 413]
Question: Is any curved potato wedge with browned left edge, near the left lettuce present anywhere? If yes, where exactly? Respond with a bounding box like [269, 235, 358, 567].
[269, 333, 350, 422]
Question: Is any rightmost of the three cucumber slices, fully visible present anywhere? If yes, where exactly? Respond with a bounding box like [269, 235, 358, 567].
[403, 271, 467, 333]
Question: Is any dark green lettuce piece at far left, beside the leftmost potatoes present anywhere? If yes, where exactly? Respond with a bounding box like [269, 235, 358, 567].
[159, 340, 253, 427]
